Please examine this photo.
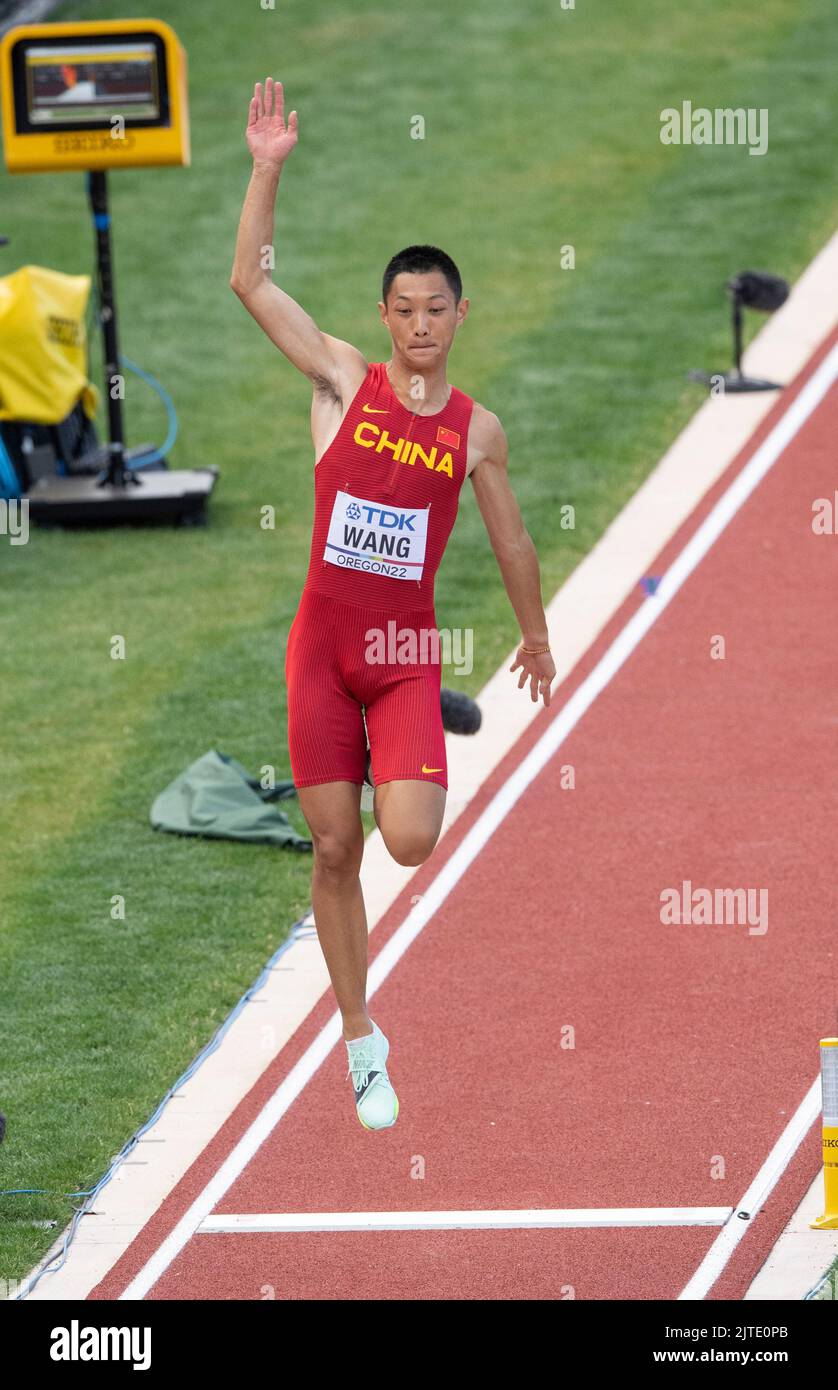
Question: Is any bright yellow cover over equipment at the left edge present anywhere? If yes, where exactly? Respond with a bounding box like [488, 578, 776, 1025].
[0, 265, 99, 425]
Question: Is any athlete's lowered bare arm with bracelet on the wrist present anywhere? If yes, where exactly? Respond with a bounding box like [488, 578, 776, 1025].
[468, 403, 556, 706]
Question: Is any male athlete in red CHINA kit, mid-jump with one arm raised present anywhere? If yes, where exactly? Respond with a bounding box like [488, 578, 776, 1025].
[231, 78, 556, 1129]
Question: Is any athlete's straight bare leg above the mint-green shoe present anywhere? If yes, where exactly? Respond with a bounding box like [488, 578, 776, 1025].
[297, 781, 372, 1038]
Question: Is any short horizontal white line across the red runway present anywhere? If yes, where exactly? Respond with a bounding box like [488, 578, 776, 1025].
[196, 1207, 732, 1236]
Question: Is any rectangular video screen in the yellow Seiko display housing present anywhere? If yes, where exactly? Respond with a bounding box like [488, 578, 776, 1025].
[24, 40, 161, 131]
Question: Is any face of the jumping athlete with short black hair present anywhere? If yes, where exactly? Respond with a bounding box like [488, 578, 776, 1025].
[378, 270, 468, 373]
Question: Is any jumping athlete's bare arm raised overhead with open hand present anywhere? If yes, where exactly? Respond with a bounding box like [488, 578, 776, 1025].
[229, 78, 367, 402]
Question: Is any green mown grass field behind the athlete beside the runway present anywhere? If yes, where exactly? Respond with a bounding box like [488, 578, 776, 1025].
[0, 0, 838, 1279]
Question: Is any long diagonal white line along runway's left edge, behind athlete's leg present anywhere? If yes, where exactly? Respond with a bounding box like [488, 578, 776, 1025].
[120, 346, 838, 1300]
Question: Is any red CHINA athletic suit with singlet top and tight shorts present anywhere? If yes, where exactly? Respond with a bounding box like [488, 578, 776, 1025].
[285, 363, 474, 787]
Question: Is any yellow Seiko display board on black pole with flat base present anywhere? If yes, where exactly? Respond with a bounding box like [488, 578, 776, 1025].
[0, 19, 218, 525]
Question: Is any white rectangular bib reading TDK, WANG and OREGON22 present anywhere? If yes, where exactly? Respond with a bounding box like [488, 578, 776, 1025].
[322, 492, 431, 580]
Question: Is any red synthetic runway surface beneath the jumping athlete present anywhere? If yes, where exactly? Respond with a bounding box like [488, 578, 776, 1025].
[90, 328, 838, 1300]
